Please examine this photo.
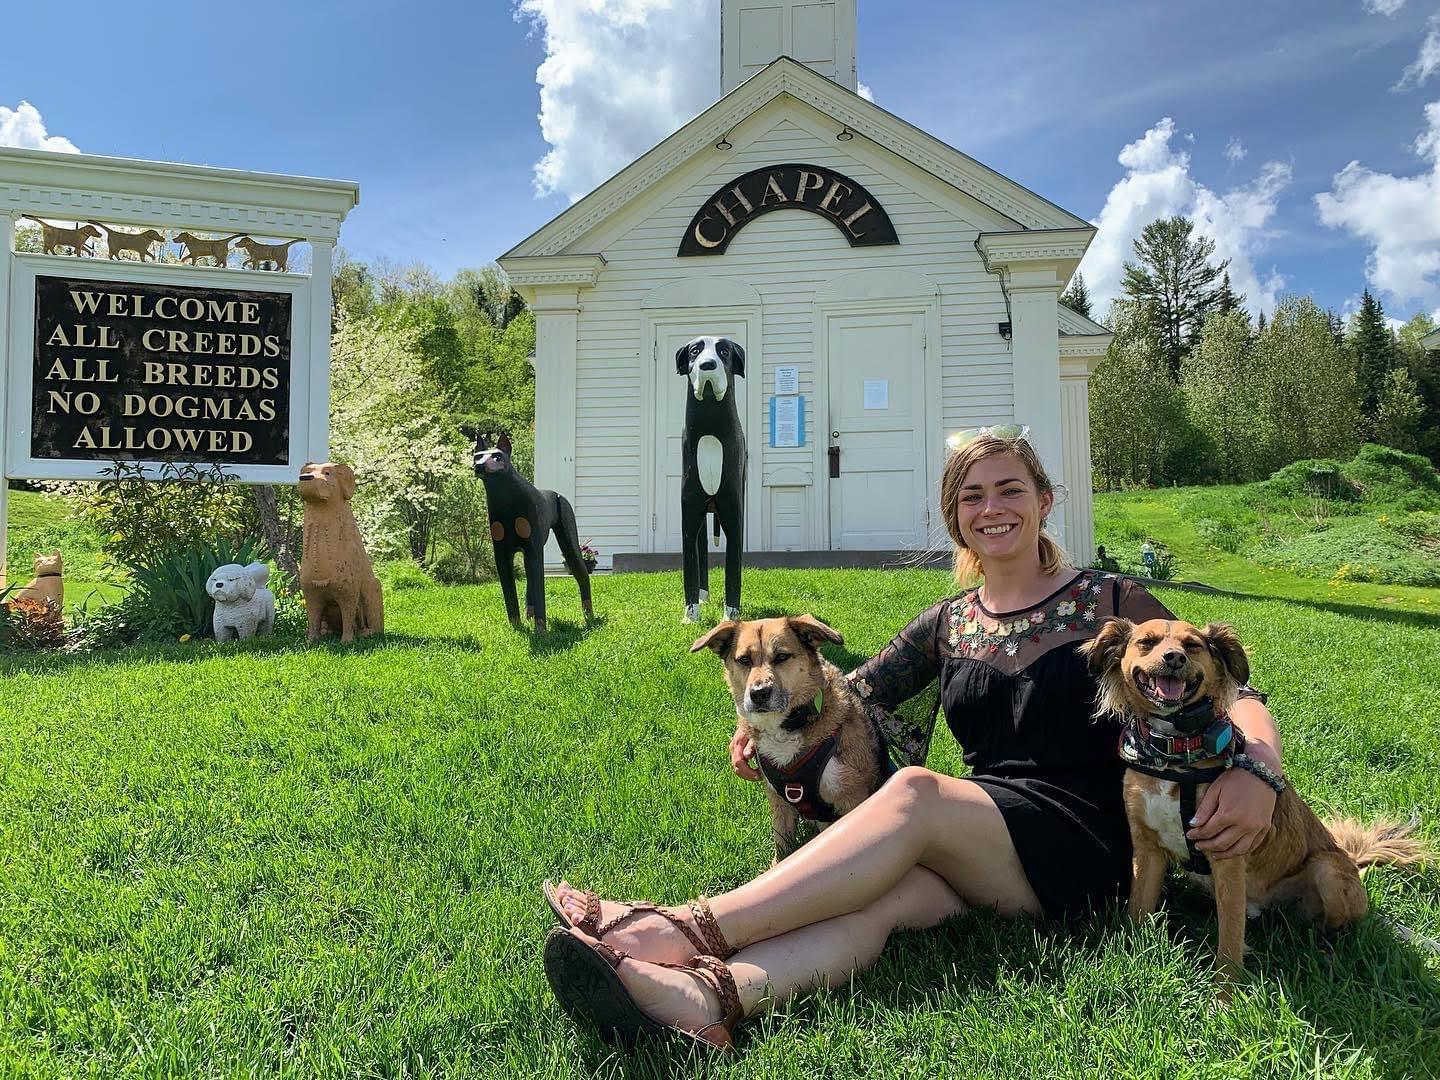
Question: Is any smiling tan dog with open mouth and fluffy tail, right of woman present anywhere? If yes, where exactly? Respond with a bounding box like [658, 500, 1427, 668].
[1080, 618, 1426, 994]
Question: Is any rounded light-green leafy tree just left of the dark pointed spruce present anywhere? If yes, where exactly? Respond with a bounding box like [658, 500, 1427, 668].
[1251, 297, 1361, 472]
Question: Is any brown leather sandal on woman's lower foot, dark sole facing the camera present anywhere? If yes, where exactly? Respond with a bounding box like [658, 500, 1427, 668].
[544, 926, 744, 1051]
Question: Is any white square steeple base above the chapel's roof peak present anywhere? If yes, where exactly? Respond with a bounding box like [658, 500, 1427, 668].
[720, 0, 857, 94]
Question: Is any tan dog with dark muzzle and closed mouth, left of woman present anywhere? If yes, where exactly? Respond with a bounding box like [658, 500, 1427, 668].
[690, 615, 894, 861]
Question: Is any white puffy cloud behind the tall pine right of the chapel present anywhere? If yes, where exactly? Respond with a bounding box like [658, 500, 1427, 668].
[1080, 117, 1292, 321]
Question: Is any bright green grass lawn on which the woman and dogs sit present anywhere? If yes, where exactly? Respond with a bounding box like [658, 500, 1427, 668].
[0, 570, 1440, 1080]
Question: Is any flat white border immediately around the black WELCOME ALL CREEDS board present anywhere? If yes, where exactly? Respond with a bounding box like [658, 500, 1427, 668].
[0, 253, 312, 484]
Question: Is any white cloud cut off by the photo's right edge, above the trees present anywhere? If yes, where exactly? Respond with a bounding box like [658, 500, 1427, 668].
[1315, 101, 1440, 304]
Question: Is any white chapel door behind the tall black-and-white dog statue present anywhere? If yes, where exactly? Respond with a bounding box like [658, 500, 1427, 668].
[648, 318, 760, 552]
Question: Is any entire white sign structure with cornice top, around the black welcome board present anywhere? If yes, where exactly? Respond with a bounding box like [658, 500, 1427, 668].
[0, 147, 360, 585]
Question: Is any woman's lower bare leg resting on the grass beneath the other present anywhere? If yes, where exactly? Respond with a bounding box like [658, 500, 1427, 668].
[567, 867, 966, 1031]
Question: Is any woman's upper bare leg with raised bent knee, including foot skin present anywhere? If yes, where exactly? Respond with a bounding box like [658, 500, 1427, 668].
[563, 768, 1040, 962]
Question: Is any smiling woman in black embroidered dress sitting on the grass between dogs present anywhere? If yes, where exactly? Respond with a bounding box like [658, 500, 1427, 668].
[546, 431, 1280, 1045]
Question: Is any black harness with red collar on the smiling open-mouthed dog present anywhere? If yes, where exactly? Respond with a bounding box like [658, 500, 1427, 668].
[1120, 698, 1246, 876]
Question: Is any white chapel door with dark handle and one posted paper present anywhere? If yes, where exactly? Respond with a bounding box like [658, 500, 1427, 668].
[824, 312, 930, 552]
